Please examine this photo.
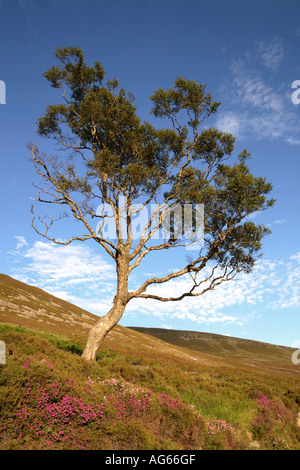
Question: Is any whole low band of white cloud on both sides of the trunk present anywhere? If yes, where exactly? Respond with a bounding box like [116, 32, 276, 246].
[11, 237, 300, 326]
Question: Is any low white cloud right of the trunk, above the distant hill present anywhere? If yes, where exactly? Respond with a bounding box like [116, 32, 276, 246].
[127, 253, 300, 325]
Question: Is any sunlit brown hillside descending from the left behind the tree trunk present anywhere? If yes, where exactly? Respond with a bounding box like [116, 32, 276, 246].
[0, 274, 227, 363]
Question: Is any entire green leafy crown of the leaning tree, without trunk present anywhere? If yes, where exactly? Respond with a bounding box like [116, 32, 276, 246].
[34, 47, 274, 280]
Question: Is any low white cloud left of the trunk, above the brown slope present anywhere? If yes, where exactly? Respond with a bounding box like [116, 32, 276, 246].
[11, 242, 115, 315]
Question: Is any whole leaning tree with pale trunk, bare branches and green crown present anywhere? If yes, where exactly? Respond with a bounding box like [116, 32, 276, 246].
[30, 47, 274, 360]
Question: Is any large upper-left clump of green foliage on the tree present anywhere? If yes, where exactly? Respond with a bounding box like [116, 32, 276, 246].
[38, 47, 168, 195]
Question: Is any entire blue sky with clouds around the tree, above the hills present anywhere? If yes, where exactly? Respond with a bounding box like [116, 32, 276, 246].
[0, 0, 300, 346]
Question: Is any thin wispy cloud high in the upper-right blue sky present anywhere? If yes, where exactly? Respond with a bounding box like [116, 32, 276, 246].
[216, 37, 300, 145]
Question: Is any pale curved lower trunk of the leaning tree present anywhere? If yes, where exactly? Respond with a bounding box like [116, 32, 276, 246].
[82, 253, 128, 361]
